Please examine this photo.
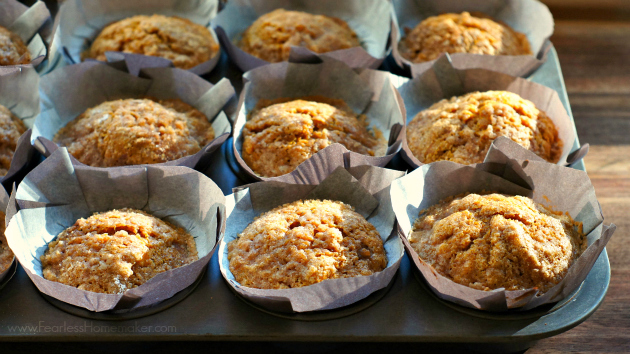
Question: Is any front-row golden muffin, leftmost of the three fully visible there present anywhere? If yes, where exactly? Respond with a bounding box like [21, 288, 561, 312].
[41, 209, 198, 294]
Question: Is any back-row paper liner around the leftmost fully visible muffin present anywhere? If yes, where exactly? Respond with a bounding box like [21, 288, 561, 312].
[56, 0, 221, 75]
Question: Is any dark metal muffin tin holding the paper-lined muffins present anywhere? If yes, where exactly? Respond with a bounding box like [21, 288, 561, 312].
[0, 43, 610, 351]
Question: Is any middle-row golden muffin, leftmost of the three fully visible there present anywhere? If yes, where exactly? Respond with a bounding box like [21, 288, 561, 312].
[53, 99, 214, 167]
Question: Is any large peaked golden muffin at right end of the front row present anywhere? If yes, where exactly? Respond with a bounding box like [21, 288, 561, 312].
[409, 194, 587, 293]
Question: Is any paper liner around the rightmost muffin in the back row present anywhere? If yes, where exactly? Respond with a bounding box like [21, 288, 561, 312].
[391, 0, 554, 76]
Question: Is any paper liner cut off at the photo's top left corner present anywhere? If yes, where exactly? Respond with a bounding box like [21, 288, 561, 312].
[0, 0, 52, 66]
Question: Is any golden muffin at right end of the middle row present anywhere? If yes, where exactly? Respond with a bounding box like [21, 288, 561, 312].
[407, 91, 563, 164]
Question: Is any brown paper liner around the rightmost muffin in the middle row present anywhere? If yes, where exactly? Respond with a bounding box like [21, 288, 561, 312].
[395, 54, 584, 169]
